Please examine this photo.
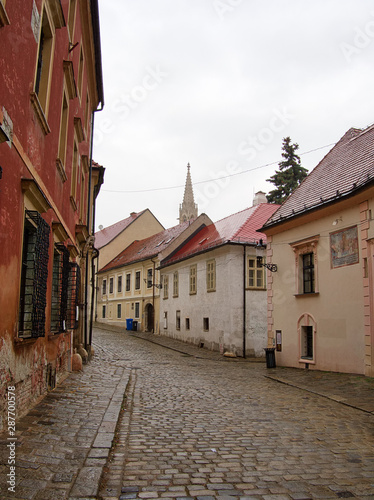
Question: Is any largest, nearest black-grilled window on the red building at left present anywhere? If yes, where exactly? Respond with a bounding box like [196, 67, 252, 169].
[18, 210, 50, 338]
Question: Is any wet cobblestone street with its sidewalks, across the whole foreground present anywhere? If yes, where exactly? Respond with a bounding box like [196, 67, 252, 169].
[0, 330, 374, 500]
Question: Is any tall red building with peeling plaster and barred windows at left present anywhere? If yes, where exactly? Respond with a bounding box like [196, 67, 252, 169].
[0, 0, 104, 429]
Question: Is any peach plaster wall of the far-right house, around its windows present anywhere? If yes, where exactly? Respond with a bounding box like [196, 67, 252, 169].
[269, 206, 365, 373]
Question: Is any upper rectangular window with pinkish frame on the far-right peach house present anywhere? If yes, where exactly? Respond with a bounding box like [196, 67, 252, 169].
[290, 235, 319, 296]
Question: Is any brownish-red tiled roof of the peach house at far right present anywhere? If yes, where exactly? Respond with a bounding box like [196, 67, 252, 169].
[264, 125, 374, 228]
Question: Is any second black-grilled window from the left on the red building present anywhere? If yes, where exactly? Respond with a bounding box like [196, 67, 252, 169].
[51, 243, 70, 333]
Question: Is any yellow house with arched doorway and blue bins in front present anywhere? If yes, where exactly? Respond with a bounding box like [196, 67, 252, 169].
[97, 215, 211, 333]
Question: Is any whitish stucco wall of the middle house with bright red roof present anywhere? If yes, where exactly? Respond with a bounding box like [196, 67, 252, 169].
[160, 245, 267, 356]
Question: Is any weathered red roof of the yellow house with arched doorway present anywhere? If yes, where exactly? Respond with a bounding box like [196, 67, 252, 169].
[100, 221, 199, 272]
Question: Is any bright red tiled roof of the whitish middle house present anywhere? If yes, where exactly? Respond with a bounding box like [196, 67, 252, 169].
[161, 203, 279, 266]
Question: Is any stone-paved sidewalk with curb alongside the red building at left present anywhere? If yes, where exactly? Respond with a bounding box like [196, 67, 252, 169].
[0, 336, 130, 500]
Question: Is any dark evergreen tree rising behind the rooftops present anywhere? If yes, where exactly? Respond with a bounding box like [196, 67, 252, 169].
[266, 137, 308, 204]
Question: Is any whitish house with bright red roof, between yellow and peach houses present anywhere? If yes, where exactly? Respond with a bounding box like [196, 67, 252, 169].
[160, 203, 277, 357]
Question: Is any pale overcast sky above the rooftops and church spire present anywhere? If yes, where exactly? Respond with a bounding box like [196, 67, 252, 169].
[94, 0, 374, 228]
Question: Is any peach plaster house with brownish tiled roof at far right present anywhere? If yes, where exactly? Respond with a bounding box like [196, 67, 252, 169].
[261, 126, 374, 376]
